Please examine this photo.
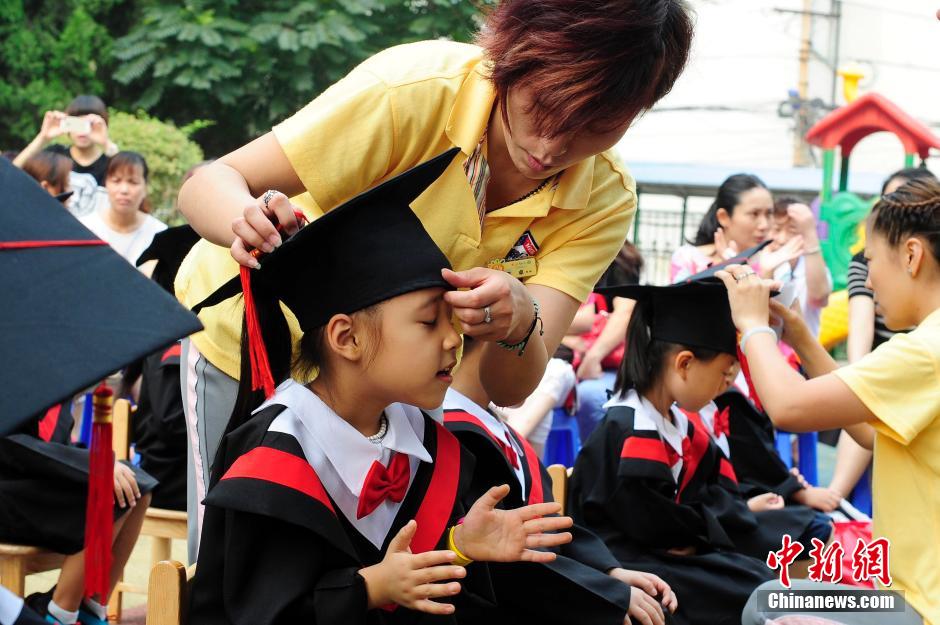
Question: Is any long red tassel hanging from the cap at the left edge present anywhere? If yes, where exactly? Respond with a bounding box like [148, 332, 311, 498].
[85, 382, 114, 603]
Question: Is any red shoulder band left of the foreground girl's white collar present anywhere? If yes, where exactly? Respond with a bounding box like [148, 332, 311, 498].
[222, 447, 336, 514]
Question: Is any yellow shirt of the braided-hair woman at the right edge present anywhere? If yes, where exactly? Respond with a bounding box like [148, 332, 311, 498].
[836, 310, 940, 625]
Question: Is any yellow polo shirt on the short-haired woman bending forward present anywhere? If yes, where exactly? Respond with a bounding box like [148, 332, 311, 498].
[176, 41, 636, 378]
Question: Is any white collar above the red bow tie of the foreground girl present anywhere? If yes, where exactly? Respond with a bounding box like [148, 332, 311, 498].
[256, 379, 432, 497]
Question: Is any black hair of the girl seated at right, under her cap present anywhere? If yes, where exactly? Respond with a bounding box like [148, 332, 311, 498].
[614, 300, 720, 395]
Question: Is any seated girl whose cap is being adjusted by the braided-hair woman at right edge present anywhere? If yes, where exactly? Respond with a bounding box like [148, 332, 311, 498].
[569, 281, 772, 624]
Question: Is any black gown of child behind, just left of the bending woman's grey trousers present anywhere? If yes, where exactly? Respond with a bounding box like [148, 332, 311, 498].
[134, 343, 186, 510]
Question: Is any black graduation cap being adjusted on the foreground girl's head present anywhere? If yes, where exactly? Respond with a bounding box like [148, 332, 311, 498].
[193, 148, 460, 331]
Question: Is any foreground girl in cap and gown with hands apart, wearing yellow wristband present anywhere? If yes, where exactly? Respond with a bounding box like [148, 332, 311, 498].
[191, 151, 571, 625]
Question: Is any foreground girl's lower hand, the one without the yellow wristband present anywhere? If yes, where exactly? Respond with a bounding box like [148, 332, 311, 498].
[359, 520, 467, 614]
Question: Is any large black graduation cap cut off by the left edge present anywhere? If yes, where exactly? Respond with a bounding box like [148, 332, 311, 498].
[0, 159, 202, 434]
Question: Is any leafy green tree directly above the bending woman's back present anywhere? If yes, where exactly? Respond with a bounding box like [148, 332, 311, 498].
[114, 0, 493, 154]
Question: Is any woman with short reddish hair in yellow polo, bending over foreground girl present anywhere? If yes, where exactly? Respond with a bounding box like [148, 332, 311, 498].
[176, 0, 693, 560]
